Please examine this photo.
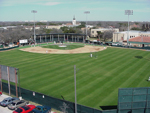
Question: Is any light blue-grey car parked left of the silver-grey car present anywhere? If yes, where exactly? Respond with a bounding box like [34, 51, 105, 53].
[0, 97, 19, 107]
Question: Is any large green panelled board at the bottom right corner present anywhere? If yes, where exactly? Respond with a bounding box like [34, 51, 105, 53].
[118, 87, 150, 113]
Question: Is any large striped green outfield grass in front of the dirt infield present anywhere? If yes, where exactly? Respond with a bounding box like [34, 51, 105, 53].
[0, 44, 150, 109]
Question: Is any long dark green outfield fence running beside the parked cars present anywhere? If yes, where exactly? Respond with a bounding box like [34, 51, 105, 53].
[2, 82, 117, 113]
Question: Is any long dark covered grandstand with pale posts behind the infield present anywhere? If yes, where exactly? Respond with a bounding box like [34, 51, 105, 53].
[32, 33, 86, 43]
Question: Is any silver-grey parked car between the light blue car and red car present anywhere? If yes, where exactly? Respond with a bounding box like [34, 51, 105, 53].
[8, 100, 29, 110]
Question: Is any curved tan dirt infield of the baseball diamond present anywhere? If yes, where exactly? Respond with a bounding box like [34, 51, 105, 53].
[20, 45, 106, 54]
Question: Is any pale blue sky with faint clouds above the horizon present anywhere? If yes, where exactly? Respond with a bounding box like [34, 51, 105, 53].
[0, 0, 150, 22]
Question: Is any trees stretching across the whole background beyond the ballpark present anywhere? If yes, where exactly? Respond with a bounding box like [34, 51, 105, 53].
[0, 21, 150, 42]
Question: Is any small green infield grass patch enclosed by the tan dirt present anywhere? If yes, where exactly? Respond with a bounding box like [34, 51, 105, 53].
[42, 45, 84, 50]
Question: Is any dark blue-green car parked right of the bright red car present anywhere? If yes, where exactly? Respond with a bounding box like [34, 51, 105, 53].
[30, 106, 51, 113]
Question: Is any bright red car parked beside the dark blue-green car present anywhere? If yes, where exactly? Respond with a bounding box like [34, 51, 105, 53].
[13, 105, 36, 113]
